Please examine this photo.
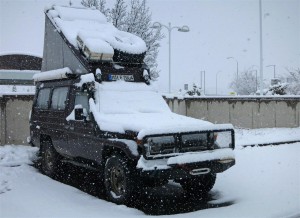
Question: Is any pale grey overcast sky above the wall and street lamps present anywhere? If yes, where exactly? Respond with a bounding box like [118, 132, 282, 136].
[0, 0, 300, 94]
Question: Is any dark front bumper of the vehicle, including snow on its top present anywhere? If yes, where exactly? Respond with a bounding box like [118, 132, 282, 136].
[137, 149, 235, 180]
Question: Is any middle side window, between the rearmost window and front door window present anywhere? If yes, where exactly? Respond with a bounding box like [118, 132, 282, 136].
[51, 87, 69, 110]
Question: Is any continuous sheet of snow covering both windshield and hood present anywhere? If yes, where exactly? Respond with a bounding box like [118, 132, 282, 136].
[90, 81, 232, 139]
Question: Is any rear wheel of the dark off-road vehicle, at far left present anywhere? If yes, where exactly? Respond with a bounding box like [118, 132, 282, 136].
[41, 140, 61, 178]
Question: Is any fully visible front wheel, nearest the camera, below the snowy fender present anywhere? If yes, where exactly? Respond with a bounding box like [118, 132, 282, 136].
[104, 154, 137, 204]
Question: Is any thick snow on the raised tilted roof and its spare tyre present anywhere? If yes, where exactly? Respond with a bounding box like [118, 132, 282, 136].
[46, 6, 147, 54]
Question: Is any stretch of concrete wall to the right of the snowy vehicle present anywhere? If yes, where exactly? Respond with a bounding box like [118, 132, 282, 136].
[166, 97, 300, 128]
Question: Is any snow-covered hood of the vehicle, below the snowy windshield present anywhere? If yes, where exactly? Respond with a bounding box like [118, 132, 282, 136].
[97, 112, 214, 139]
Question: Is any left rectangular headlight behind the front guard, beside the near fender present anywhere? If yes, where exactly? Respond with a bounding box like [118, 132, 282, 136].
[145, 136, 175, 156]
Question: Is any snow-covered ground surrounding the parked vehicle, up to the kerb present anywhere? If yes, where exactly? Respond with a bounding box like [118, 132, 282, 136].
[0, 143, 300, 218]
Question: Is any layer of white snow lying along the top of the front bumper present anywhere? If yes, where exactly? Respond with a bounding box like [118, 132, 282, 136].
[137, 148, 235, 171]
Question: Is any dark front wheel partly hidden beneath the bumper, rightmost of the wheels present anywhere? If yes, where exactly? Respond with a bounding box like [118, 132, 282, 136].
[180, 173, 217, 197]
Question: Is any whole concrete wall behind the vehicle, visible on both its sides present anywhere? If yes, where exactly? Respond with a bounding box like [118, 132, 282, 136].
[0, 95, 300, 145]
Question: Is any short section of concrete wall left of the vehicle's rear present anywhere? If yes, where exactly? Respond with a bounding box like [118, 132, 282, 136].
[0, 95, 33, 145]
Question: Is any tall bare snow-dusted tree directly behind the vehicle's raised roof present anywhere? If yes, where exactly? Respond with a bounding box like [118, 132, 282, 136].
[82, 0, 164, 80]
